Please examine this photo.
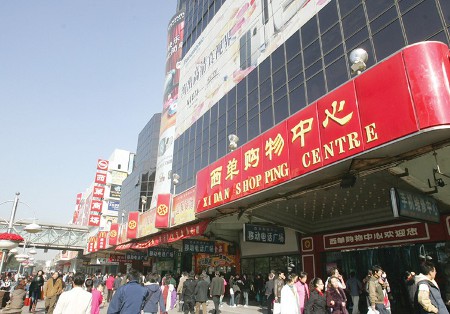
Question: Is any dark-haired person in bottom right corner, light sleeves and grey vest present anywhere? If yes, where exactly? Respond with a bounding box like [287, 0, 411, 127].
[414, 262, 449, 314]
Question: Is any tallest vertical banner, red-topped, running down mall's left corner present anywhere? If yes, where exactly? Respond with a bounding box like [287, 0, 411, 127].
[150, 11, 184, 208]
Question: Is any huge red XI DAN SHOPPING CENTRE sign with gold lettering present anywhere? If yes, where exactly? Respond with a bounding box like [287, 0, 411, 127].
[196, 43, 450, 214]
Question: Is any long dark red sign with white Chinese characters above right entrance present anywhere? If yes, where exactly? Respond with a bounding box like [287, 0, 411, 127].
[323, 222, 430, 250]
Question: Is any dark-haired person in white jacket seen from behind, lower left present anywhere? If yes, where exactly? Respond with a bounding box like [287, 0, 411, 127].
[50, 273, 92, 314]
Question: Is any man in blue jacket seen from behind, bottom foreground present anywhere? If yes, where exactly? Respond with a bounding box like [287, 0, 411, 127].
[107, 269, 149, 314]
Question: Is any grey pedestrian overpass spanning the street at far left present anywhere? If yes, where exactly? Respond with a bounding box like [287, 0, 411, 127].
[0, 220, 89, 251]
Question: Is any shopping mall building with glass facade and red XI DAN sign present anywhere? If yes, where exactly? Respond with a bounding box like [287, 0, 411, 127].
[85, 0, 450, 312]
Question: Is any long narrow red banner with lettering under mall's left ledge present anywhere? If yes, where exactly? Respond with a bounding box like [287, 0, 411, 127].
[128, 220, 209, 250]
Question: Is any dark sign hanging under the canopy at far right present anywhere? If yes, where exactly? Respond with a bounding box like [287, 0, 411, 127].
[391, 188, 440, 223]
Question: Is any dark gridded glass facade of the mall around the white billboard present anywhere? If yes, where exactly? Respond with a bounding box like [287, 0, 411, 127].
[173, 0, 450, 192]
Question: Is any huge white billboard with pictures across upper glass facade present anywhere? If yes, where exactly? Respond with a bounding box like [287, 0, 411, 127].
[175, 0, 330, 138]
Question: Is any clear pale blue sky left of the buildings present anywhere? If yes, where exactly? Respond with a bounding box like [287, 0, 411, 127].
[0, 0, 176, 248]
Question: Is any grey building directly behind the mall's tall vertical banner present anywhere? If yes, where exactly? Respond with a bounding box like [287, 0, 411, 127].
[119, 113, 161, 218]
